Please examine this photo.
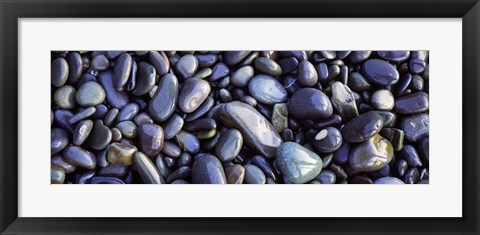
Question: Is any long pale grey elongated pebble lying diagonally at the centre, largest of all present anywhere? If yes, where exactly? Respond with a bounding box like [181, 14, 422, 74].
[220, 101, 282, 158]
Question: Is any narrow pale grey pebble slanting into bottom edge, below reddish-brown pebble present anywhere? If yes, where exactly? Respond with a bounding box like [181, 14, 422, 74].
[133, 152, 165, 184]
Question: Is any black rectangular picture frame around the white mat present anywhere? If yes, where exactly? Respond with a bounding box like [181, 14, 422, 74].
[0, 0, 480, 234]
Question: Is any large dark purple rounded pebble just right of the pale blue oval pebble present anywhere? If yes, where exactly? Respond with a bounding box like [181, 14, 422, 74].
[288, 88, 333, 119]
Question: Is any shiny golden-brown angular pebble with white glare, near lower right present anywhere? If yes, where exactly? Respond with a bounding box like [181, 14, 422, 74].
[349, 135, 393, 171]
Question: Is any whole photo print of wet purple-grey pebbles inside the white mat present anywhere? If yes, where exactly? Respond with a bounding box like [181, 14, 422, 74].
[51, 51, 429, 184]
